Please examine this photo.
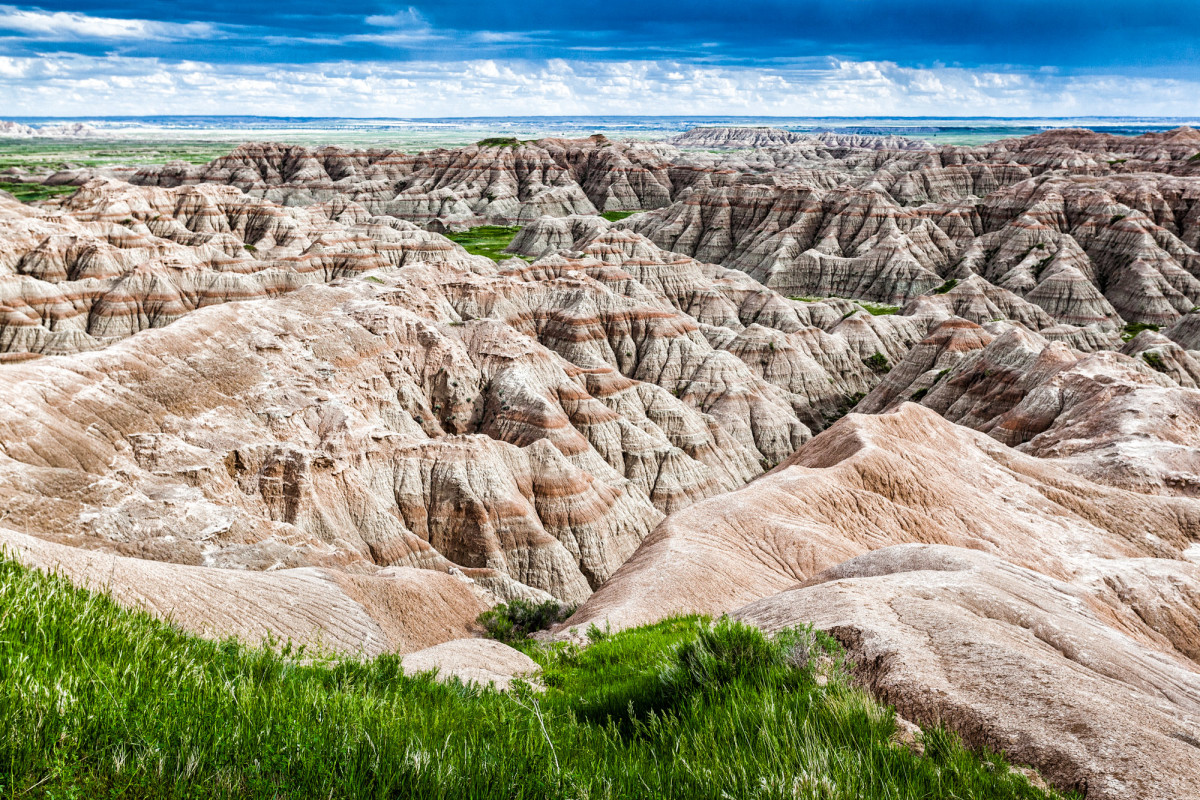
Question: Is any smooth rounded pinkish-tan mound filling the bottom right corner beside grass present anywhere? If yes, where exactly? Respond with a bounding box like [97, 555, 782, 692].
[737, 545, 1200, 800]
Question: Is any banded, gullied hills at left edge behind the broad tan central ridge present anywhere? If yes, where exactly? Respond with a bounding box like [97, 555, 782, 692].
[0, 179, 491, 354]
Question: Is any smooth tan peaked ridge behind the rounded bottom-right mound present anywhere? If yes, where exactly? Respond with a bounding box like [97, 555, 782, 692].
[569, 404, 1200, 626]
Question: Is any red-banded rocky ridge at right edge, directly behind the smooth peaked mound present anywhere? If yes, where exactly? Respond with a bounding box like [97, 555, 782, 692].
[856, 320, 1200, 495]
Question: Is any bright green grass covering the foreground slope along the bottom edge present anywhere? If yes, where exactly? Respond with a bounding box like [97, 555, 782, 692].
[0, 561, 1070, 800]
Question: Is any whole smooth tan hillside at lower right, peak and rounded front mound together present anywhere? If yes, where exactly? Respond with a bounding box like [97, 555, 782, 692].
[564, 404, 1200, 800]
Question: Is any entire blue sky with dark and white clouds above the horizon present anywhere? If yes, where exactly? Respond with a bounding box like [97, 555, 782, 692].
[0, 0, 1200, 118]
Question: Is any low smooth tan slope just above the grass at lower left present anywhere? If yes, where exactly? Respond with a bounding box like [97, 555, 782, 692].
[0, 528, 487, 656]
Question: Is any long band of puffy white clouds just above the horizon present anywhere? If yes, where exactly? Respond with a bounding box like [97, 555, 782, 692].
[0, 54, 1200, 116]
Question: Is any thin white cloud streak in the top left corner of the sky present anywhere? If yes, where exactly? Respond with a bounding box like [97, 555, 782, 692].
[0, 6, 217, 42]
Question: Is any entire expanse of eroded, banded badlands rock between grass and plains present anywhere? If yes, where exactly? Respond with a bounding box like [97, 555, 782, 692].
[0, 128, 1200, 799]
